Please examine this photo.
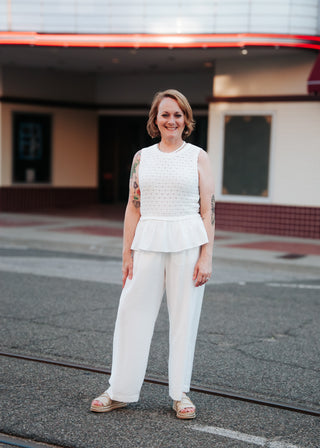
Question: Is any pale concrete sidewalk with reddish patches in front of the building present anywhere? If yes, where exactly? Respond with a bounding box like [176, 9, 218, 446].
[0, 206, 320, 269]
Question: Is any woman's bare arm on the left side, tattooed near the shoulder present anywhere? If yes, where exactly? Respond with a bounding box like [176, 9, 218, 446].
[122, 151, 141, 287]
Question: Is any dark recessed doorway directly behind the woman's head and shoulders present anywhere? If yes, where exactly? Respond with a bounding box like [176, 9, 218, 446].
[99, 115, 208, 203]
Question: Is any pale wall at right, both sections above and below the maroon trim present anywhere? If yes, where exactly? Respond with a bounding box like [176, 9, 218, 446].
[208, 51, 320, 207]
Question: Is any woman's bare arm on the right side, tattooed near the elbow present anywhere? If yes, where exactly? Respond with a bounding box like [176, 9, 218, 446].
[193, 151, 215, 286]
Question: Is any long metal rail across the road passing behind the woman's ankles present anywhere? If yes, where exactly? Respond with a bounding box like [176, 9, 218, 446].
[0, 352, 320, 417]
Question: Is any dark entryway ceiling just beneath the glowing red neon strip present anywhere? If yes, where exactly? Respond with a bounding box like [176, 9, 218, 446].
[0, 45, 311, 73]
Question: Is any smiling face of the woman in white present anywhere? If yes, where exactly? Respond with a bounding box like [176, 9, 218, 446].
[156, 98, 185, 139]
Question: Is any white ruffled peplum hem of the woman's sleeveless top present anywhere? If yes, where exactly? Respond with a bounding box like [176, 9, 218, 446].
[131, 214, 208, 252]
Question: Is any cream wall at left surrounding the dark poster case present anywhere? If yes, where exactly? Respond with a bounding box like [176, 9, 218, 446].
[0, 103, 98, 187]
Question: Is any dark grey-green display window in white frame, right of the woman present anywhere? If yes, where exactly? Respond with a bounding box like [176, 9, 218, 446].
[222, 115, 272, 197]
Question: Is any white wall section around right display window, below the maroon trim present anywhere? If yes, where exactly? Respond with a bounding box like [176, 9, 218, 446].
[208, 102, 320, 207]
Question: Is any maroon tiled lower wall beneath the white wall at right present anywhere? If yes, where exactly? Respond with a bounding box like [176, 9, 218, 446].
[216, 202, 320, 238]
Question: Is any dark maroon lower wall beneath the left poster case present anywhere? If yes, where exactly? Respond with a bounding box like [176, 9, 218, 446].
[0, 187, 98, 212]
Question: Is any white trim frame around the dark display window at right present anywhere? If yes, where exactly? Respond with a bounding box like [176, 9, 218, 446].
[216, 109, 276, 204]
